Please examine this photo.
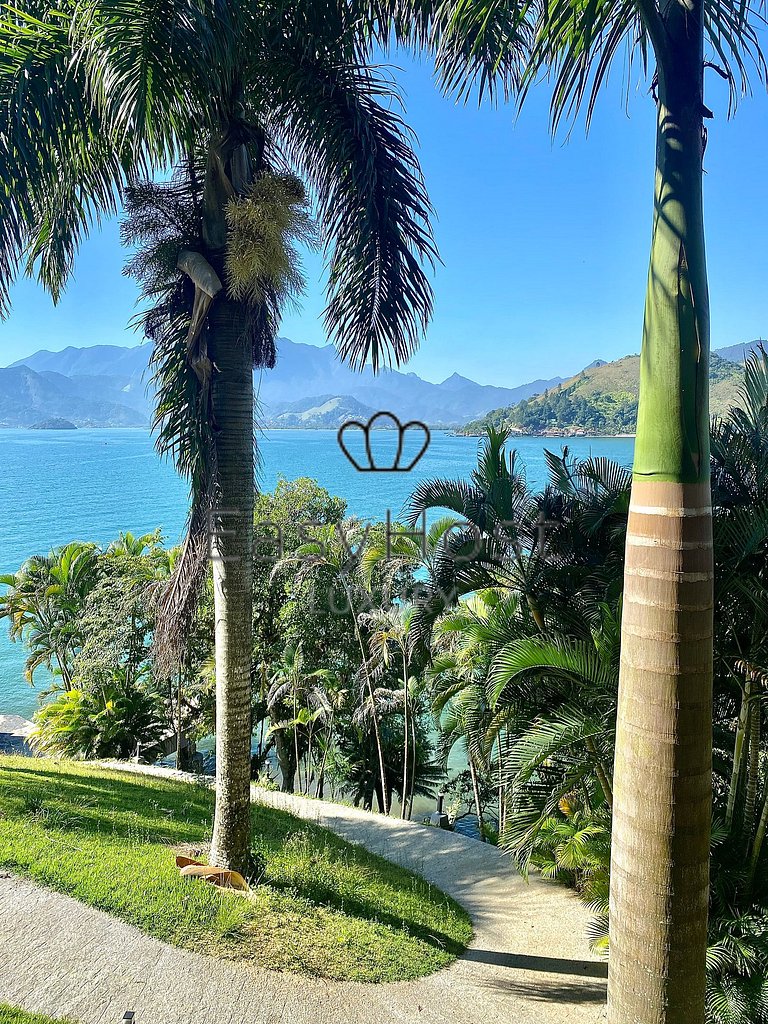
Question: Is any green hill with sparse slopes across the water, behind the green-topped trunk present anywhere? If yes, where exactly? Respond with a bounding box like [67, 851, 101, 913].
[463, 352, 743, 435]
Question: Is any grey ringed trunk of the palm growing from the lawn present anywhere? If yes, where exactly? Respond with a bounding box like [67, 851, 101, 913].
[209, 299, 254, 871]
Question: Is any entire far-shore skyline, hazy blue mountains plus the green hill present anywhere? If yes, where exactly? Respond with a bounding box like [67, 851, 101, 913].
[0, 338, 759, 434]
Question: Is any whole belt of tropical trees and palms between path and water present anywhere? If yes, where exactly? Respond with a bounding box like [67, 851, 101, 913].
[0, 353, 768, 1024]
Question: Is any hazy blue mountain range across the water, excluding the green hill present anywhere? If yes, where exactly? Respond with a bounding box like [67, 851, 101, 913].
[0, 338, 562, 427]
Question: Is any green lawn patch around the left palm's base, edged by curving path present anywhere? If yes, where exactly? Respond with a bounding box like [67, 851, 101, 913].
[0, 757, 471, 978]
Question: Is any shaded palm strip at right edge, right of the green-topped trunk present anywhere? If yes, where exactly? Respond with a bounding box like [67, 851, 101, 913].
[708, 351, 768, 1024]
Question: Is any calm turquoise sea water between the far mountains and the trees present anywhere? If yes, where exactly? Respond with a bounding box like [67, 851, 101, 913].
[0, 430, 633, 717]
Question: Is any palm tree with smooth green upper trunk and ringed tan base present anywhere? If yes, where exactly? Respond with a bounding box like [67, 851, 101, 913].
[392, 6, 765, 1024]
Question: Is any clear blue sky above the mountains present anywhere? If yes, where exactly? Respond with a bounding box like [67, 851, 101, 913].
[0, 55, 768, 385]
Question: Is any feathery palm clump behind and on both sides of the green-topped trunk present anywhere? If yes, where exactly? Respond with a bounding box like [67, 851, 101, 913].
[412, 352, 768, 1024]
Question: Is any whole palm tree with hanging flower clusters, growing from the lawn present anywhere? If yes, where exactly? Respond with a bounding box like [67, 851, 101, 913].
[0, 0, 434, 869]
